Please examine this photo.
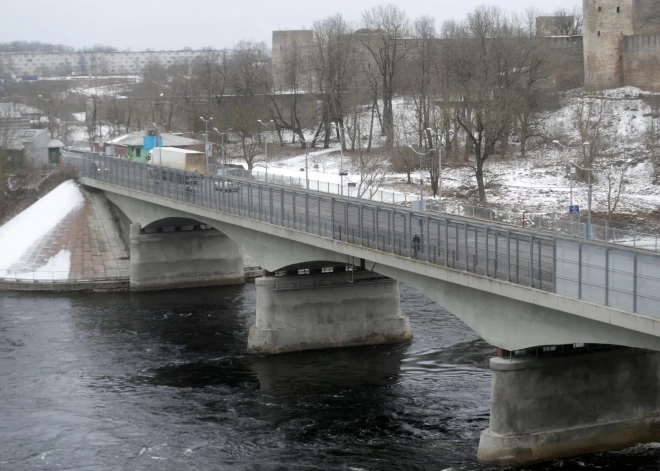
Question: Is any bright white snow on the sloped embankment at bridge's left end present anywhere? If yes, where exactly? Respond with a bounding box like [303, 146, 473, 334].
[0, 181, 85, 278]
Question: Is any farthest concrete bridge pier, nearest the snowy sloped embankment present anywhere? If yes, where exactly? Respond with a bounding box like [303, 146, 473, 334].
[130, 223, 245, 291]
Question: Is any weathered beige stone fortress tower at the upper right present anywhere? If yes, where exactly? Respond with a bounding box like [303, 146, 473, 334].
[582, 0, 635, 89]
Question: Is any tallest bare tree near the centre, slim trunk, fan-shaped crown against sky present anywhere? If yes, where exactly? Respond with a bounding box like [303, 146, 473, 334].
[360, 4, 409, 148]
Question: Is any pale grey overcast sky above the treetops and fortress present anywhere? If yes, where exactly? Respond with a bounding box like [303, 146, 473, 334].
[5, 0, 582, 51]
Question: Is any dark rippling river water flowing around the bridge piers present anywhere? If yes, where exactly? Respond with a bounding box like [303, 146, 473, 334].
[0, 284, 660, 471]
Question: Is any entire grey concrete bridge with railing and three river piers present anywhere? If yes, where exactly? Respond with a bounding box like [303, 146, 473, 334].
[72, 156, 660, 465]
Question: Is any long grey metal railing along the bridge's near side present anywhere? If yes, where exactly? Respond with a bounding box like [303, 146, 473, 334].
[77, 156, 660, 317]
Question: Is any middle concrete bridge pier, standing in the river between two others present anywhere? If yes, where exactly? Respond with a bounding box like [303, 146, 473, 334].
[248, 273, 412, 353]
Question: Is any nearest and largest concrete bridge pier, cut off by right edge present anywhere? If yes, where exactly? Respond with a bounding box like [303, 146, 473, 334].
[478, 349, 660, 466]
